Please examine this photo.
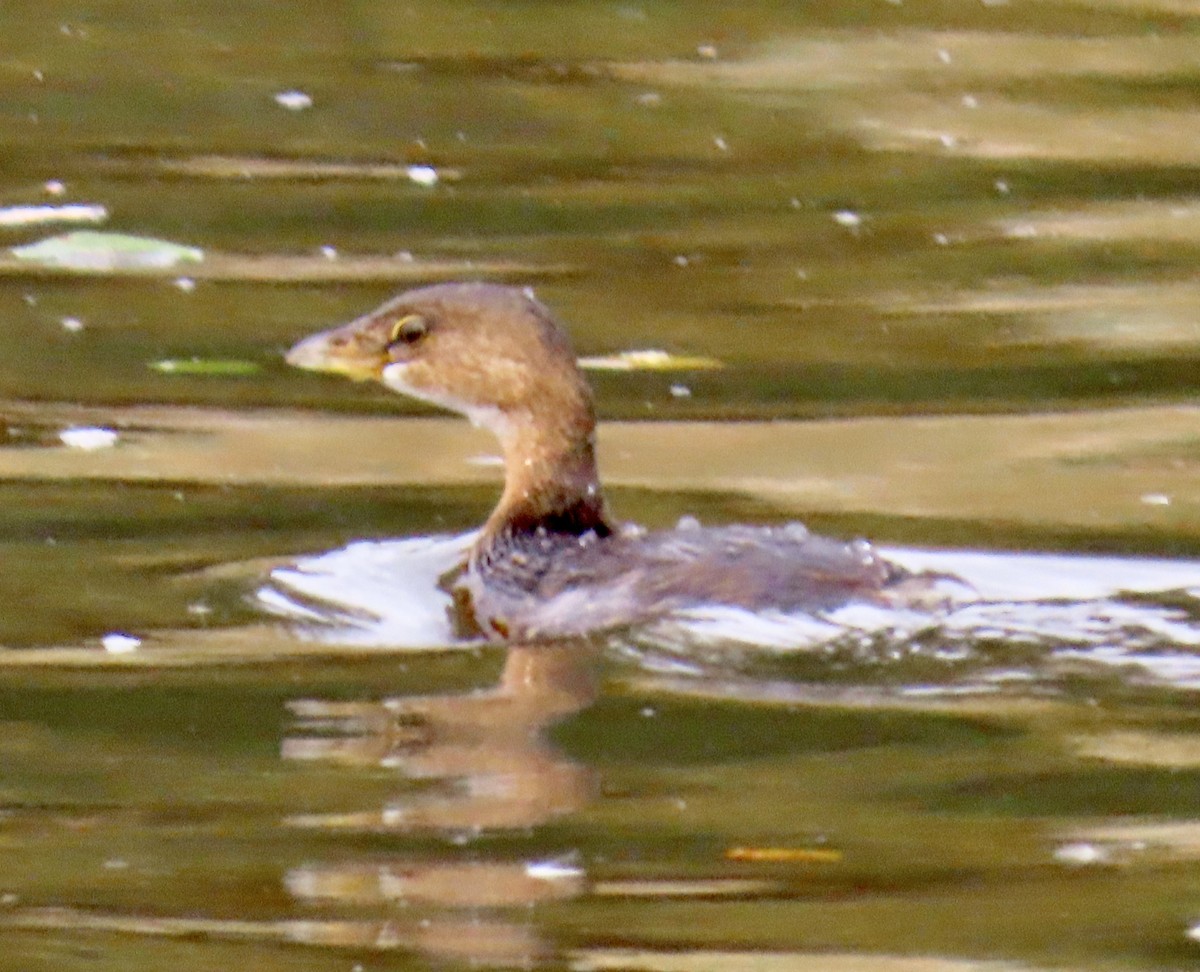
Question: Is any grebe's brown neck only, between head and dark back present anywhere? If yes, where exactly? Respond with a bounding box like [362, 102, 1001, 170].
[476, 400, 612, 551]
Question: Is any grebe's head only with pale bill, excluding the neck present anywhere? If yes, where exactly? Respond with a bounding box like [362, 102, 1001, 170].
[287, 283, 592, 439]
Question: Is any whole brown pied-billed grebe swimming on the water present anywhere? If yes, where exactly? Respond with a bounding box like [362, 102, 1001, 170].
[287, 283, 924, 640]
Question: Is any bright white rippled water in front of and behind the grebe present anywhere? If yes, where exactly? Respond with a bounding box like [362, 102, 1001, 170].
[257, 533, 1200, 689]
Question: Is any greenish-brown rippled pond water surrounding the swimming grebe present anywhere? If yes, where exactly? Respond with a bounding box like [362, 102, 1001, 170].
[0, 0, 1200, 972]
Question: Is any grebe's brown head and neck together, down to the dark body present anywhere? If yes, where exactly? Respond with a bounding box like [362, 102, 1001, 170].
[287, 283, 610, 540]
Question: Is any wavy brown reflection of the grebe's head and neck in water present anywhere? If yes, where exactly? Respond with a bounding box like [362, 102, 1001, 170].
[283, 644, 596, 965]
